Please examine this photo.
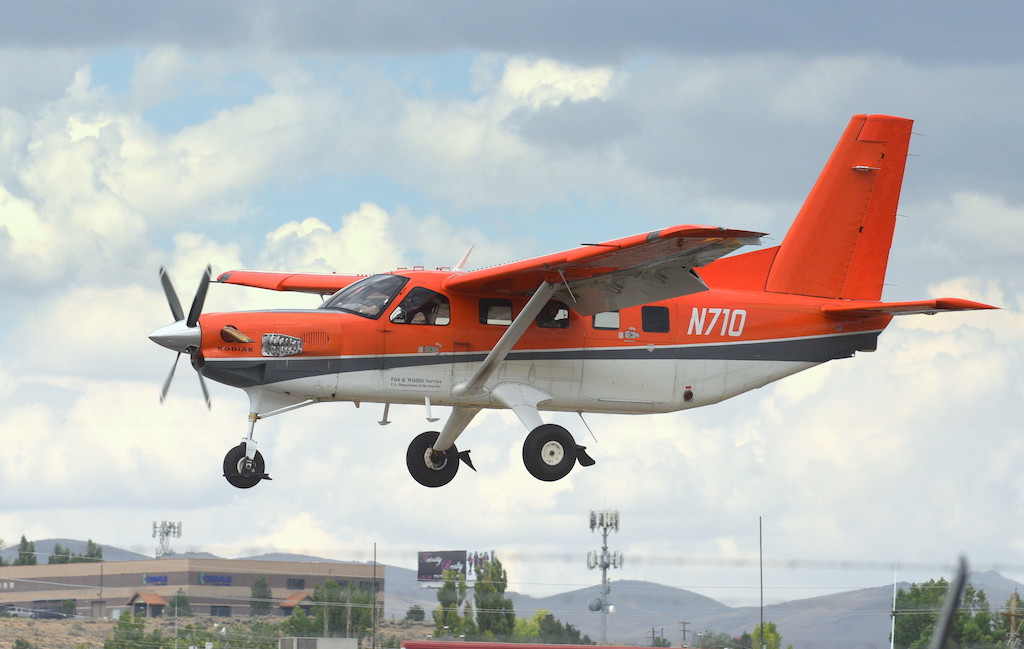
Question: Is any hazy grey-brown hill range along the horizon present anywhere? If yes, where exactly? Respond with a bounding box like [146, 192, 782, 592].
[0, 538, 1024, 649]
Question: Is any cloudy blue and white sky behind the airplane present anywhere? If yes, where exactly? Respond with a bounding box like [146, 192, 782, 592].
[0, 0, 1024, 618]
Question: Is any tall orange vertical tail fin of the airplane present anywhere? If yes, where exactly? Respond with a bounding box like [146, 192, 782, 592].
[765, 115, 913, 300]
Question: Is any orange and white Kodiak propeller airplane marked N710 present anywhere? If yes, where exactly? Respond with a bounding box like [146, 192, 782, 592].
[150, 115, 996, 488]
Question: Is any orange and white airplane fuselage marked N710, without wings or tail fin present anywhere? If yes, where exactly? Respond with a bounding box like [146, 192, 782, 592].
[192, 270, 891, 414]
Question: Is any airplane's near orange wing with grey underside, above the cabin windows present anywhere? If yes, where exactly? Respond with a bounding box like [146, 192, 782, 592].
[446, 225, 763, 315]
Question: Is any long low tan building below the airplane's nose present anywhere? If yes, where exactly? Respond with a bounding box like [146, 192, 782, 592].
[0, 558, 384, 617]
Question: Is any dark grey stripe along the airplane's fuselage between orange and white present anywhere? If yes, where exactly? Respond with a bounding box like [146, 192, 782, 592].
[203, 332, 882, 388]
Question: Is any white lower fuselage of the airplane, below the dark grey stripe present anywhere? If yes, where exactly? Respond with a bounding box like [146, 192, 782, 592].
[204, 334, 880, 414]
